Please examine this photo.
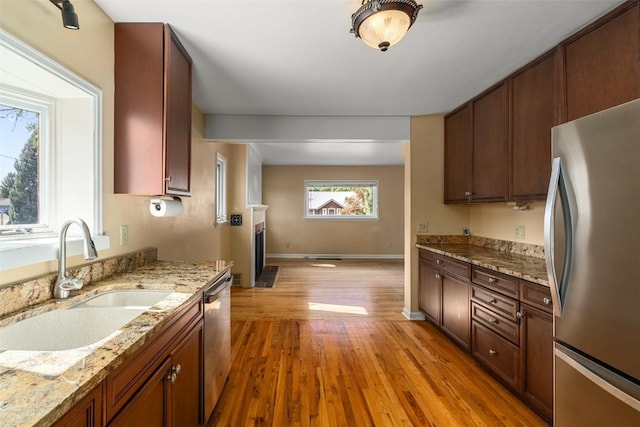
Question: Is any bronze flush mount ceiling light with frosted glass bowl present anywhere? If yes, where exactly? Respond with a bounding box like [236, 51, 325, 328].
[351, 0, 422, 52]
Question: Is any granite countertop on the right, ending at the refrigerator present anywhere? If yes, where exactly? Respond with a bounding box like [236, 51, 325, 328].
[416, 243, 549, 286]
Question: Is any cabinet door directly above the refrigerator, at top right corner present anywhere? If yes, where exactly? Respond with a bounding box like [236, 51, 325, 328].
[561, 2, 640, 121]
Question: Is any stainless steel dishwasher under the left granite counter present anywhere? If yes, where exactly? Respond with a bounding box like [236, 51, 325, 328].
[203, 271, 231, 422]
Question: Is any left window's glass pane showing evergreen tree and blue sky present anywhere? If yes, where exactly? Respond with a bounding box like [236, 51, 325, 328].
[0, 103, 40, 226]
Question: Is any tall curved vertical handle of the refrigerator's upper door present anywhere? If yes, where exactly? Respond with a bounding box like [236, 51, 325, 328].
[544, 157, 573, 317]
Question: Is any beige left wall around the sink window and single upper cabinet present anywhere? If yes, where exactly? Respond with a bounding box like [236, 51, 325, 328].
[0, 0, 231, 284]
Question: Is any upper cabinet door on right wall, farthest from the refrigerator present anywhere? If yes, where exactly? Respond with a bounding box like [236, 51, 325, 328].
[444, 105, 472, 202]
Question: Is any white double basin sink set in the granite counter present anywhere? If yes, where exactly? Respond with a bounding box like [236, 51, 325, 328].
[0, 289, 173, 351]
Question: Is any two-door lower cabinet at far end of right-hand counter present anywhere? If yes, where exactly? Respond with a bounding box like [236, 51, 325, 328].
[418, 251, 470, 350]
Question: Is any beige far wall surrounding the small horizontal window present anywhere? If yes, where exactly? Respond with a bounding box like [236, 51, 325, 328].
[262, 166, 404, 255]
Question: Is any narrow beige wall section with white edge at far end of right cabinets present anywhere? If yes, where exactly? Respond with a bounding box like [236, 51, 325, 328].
[404, 115, 470, 314]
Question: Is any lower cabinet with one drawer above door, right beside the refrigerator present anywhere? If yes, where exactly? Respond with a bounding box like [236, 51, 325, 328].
[520, 281, 553, 421]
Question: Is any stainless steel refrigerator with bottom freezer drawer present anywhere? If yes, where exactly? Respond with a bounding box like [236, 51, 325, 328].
[544, 99, 640, 427]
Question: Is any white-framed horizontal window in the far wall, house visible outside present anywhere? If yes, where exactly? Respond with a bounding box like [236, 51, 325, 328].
[305, 181, 378, 219]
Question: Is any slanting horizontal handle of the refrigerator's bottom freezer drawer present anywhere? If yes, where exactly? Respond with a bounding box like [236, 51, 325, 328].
[554, 346, 640, 412]
